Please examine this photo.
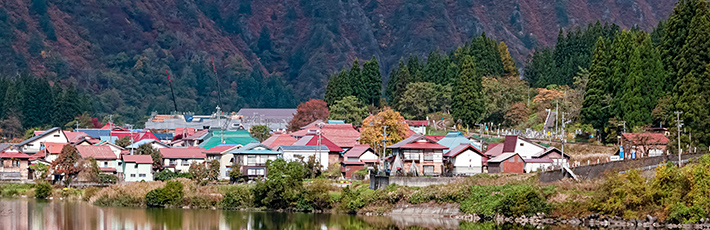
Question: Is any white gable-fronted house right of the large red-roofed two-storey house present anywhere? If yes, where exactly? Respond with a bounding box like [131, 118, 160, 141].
[444, 143, 488, 175]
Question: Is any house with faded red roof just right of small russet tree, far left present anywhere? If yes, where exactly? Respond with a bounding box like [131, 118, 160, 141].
[75, 145, 123, 177]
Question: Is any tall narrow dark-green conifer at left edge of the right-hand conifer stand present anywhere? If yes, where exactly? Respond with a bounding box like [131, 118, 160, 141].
[580, 37, 611, 130]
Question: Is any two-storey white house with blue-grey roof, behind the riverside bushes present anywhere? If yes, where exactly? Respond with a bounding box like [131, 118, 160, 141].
[230, 142, 281, 179]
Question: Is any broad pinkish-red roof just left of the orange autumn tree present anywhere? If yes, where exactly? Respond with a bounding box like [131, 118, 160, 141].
[291, 124, 360, 148]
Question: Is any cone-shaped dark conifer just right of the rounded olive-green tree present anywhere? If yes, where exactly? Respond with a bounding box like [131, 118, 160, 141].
[451, 57, 485, 126]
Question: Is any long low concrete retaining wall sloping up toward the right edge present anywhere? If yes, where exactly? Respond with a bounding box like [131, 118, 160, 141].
[540, 154, 704, 182]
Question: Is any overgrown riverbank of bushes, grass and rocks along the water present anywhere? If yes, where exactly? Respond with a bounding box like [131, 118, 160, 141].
[0, 156, 710, 227]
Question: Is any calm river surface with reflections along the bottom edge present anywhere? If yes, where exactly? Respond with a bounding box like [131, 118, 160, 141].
[0, 199, 572, 230]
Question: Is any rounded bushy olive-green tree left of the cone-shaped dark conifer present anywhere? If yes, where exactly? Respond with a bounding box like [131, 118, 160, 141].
[397, 82, 451, 119]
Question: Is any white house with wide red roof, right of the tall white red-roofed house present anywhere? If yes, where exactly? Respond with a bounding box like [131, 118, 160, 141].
[158, 147, 206, 172]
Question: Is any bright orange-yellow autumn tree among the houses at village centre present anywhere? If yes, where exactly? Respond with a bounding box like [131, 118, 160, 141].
[360, 108, 409, 153]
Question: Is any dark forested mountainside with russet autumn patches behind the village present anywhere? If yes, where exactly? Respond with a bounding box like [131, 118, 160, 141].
[0, 0, 674, 119]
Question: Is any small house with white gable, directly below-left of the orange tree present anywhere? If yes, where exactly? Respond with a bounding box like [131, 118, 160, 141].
[340, 145, 380, 178]
